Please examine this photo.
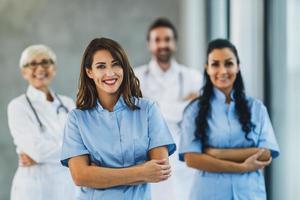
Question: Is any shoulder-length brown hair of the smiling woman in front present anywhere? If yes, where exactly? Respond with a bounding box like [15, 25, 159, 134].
[76, 38, 142, 110]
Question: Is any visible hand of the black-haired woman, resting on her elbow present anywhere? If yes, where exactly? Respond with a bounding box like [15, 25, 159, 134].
[242, 149, 272, 172]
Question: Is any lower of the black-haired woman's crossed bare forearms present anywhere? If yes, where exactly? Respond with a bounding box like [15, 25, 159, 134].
[184, 153, 247, 173]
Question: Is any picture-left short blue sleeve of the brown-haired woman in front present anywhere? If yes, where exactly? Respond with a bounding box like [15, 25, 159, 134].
[61, 110, 89, 167]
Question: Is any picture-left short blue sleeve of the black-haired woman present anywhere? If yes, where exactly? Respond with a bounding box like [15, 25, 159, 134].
[179, 101, 202, 161]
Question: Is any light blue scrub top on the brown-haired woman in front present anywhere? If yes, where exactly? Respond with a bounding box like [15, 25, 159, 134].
[61, 97, 176, 200]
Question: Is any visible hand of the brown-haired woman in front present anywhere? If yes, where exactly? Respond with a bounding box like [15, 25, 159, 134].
[141, 159, 171, 183]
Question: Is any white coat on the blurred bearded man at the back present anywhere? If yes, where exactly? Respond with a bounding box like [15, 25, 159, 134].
[135, 59, 202, 200]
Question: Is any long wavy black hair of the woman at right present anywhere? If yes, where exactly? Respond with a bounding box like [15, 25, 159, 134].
[195, 39, 254, 148]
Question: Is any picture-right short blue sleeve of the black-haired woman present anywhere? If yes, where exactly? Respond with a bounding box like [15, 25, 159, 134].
[258, 105, 279, 158]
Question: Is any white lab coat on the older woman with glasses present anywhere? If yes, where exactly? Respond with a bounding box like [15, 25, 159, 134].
[8, 86, 76, 200]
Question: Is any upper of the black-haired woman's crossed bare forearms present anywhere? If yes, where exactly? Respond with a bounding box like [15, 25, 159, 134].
[205, 147, 271, 163]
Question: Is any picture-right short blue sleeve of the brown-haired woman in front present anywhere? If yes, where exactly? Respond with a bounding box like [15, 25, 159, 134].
[148, 103, 176, 155]
